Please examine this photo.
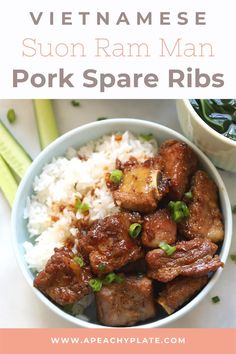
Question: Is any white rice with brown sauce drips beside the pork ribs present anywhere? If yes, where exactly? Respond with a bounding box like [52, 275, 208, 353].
[24, 132, 157, 271]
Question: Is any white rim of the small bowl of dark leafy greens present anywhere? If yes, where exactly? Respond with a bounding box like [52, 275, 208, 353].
[180, 99, 236, 147]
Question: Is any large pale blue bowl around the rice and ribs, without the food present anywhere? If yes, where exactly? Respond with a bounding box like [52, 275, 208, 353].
[12, 119, 232, 328]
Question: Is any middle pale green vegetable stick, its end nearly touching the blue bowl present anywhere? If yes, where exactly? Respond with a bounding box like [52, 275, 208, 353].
[0, 121, 32, 178]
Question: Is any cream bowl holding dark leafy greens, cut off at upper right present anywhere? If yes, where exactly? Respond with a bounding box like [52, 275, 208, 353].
[176, 99, 236, 172]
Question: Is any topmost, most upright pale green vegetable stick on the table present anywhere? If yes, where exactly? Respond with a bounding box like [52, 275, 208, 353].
[33, 99, 58, 149]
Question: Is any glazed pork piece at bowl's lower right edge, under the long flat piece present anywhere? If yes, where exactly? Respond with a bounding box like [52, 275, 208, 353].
[157, 275, 208, 315]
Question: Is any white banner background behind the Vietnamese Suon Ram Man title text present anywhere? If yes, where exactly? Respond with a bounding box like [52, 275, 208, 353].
[0, 0, 236, 98]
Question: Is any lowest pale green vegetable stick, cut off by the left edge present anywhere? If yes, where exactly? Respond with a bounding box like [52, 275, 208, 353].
[0, 155, 17, 207]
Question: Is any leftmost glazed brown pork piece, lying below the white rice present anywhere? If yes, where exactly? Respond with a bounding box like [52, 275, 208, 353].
[34, 247, 92, 305]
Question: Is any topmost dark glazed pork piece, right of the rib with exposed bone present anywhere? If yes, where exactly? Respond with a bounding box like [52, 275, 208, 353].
[160, 140, 198, 200]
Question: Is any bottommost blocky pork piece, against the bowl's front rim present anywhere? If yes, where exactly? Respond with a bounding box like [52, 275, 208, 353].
[96, 276, 156, 326]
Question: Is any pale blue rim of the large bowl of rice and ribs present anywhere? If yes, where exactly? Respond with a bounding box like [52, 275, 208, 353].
[11, 118, 232, 328]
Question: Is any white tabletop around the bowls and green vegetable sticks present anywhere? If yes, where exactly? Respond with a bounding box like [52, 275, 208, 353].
[0, 100, 236, 328]
